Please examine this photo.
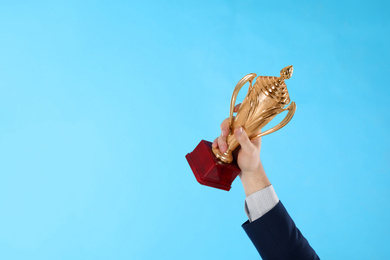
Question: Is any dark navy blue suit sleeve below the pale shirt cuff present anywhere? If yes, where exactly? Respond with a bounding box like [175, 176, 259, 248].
[242, 201, 319, 260]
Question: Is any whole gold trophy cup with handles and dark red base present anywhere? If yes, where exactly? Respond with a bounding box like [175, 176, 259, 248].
[186, 66, 296, 191]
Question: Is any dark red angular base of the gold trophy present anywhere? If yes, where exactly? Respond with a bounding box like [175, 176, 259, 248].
[186, 140, 241, 191]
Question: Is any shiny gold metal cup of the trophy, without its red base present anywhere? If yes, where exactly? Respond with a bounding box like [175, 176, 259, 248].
[213, 66, 296, 163]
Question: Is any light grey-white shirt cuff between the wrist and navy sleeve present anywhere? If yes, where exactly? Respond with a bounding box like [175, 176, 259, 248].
[245, 185, 279, 222]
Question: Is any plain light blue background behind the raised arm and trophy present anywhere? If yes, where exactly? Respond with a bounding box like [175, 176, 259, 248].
[0, 1, 390, 259]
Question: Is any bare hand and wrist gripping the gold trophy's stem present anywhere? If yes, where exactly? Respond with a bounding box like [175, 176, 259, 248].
[213, 105, 271, 196]
